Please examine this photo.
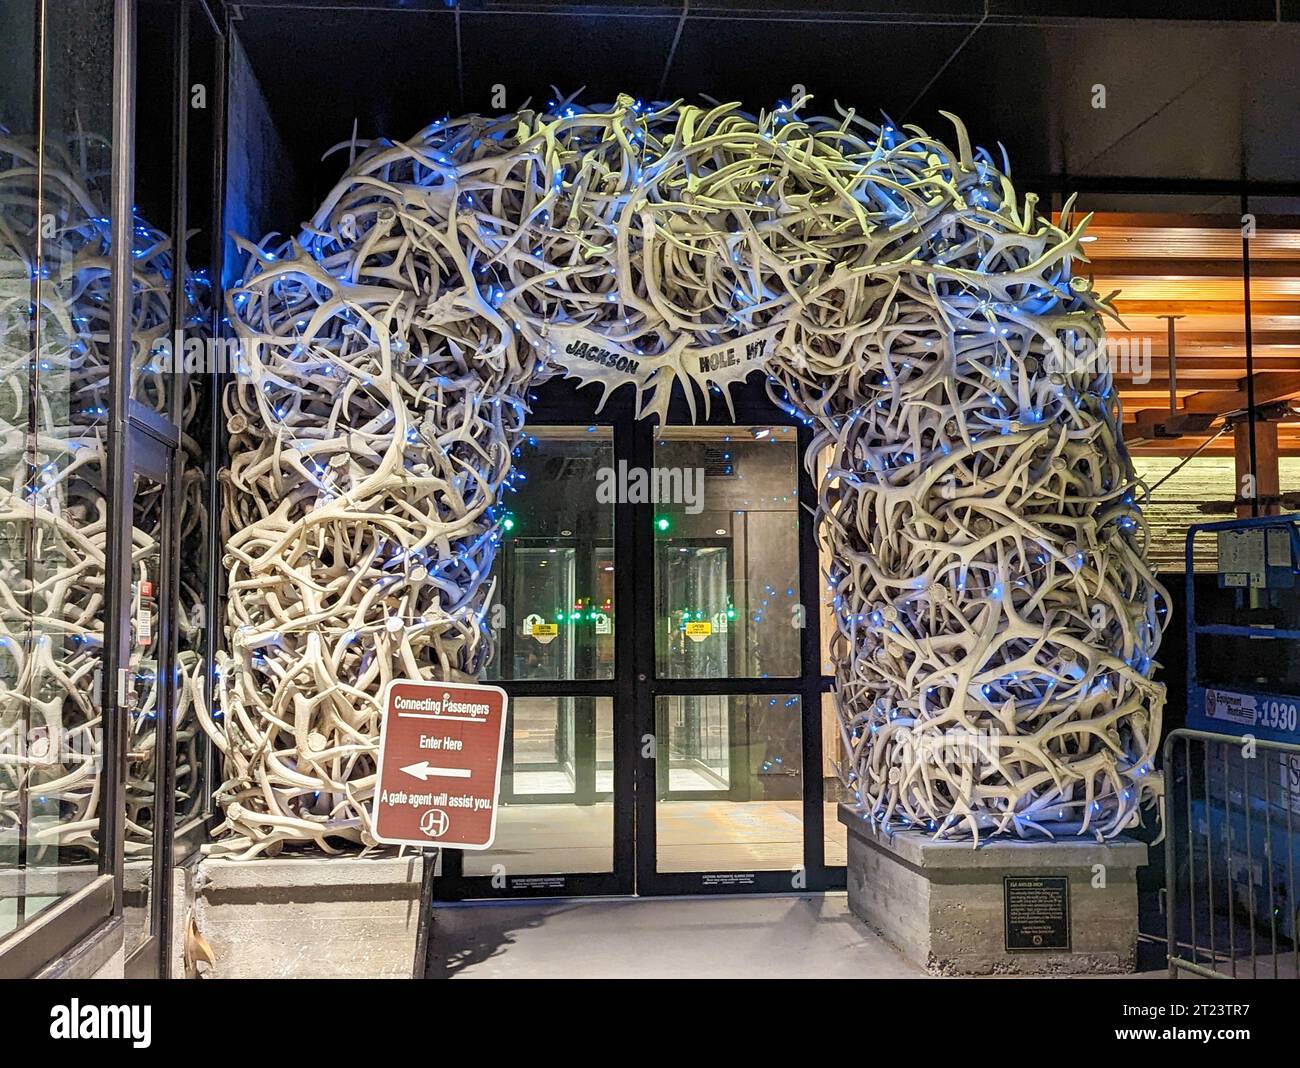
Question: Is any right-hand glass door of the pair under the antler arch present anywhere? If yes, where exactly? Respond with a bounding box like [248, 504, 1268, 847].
[637, 422, 823, 893]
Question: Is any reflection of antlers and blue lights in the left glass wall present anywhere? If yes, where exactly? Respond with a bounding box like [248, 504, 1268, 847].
[0, 135, 205, 850]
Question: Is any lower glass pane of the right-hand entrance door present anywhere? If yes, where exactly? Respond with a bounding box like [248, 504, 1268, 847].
[655, 694, 803, 872]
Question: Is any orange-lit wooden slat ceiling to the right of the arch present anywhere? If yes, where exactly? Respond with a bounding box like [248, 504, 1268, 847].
[1075, 212, 1300, 456]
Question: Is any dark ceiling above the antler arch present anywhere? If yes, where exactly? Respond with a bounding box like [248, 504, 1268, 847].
[228, 0, 1300, 216]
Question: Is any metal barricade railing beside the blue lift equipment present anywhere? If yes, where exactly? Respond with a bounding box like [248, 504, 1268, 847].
[1165, 729, 1300, 978]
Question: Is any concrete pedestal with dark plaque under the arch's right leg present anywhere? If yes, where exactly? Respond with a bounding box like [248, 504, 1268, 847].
[840, 804, 1147, 976]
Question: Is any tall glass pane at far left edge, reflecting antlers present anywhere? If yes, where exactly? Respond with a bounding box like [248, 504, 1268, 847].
[0, 0, 113, 951]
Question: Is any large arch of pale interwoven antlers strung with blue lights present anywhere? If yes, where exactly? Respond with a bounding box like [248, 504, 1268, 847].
[208, 97, 1164, 856]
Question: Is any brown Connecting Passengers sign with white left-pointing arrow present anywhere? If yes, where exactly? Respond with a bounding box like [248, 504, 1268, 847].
[371, 680, 506, 850]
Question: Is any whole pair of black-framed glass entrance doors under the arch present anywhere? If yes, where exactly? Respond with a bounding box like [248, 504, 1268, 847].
[438, 392, 842, 898]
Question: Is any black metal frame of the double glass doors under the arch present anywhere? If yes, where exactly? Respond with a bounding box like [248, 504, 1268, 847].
[434, 381, 845, 900]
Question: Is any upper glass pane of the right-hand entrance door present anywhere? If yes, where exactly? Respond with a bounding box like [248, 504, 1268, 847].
[650, 426, 802, 678]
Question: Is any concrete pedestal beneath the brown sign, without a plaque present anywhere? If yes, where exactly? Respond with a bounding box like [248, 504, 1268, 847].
[185, 855, 423, 978]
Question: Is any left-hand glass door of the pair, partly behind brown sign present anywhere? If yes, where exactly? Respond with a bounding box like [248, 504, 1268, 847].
[442, 425, 632, 896]
